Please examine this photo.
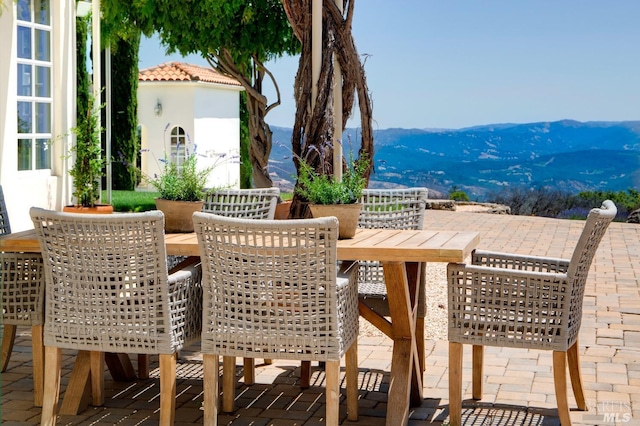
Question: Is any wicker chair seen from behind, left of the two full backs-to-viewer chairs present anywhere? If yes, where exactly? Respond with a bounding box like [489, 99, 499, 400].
[30, 208, 202, 425]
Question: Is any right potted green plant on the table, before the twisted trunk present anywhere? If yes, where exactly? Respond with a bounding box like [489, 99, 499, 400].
[294, 144, 369, 239]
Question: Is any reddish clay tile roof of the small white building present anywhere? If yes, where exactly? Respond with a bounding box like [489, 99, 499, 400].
[138, 62, 241, 86]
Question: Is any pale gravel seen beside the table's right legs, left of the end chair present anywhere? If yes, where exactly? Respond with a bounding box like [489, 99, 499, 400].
[360, 262, 447, 340]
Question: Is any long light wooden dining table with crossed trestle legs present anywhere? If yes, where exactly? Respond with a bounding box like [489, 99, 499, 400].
[0, 229, 480, 426]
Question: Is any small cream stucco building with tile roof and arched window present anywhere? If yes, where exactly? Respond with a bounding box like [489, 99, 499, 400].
[138, 62, 243, 189]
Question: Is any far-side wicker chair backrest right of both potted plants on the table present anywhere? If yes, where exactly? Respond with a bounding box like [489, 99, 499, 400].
[358, 188, 428, 229]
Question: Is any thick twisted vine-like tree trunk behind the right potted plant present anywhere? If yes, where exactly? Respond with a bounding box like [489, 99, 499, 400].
[283, 0, 374, 217]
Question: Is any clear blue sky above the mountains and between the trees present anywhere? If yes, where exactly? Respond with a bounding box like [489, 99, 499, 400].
[140, 0, 640, 129]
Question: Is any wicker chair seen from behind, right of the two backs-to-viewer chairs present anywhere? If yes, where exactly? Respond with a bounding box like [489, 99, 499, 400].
[193, 213, 358, 425]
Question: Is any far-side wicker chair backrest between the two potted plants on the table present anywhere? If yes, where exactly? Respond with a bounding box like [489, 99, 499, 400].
[202, 187, 280, 219]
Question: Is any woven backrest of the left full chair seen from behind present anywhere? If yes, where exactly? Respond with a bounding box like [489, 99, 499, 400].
[29, 207, 184, 354]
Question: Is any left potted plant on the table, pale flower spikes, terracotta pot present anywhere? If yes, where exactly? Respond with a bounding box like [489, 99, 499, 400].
[147, 153, 213, 232]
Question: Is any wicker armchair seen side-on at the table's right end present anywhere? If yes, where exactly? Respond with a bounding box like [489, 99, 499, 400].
[447, 200, 617, 426]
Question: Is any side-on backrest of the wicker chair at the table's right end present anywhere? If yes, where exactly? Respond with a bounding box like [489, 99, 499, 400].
[567, 200, 618, 342]
